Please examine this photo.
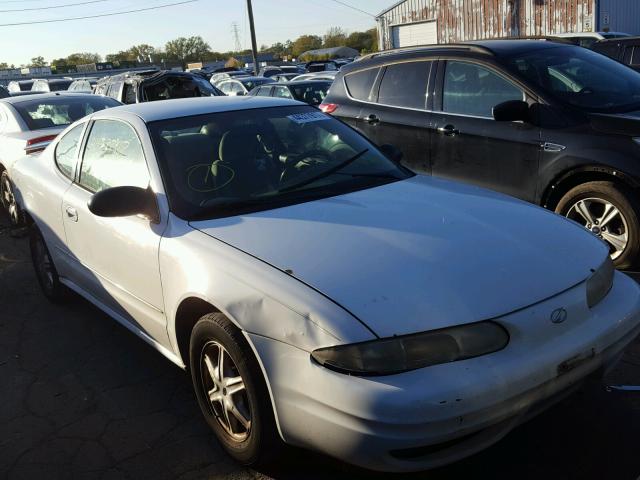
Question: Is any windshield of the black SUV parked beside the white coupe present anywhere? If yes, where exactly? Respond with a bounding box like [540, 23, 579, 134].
[504, 46, 640, 113]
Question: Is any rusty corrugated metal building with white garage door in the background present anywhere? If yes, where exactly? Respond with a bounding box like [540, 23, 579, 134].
[376, 0, 640, 49]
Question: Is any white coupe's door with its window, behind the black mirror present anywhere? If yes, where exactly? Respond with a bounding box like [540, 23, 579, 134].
[62, 119, 169, 345]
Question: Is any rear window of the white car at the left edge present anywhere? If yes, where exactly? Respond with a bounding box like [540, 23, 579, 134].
[13, 95, 121, 130]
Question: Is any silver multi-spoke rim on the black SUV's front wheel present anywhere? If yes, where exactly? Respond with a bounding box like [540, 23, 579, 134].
[567, 198, 629, 260]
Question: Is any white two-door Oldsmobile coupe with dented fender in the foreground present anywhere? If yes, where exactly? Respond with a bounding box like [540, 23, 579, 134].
[14, 97, 640, 471]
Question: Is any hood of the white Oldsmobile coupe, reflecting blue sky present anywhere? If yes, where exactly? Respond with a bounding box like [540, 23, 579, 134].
[192, 176, 607, 337]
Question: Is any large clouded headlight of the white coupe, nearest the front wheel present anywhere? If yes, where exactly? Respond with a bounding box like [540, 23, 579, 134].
[311, 322, 509, 375]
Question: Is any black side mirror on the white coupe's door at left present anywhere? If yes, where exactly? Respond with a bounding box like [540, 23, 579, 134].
[88, 187, 160, 223]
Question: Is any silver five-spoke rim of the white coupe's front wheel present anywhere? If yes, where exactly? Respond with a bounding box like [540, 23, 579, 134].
[200, 341, 251, 442]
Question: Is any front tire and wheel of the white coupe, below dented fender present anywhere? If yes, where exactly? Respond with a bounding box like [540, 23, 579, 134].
[189, 313, 282, 465]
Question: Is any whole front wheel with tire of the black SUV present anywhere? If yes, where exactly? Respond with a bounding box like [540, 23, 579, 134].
[555, 181, 640, 269]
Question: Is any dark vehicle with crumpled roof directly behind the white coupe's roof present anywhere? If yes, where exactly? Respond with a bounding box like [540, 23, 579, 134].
[95, 70, 222, 103]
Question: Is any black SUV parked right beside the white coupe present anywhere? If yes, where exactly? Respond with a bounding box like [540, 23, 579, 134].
[321, 40, 640, 268]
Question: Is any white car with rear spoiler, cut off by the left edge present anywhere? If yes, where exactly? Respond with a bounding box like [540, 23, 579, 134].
[0, 93, 121, 224]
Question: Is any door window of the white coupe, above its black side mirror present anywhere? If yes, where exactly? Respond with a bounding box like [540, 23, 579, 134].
[80, 120, 149, 192]
